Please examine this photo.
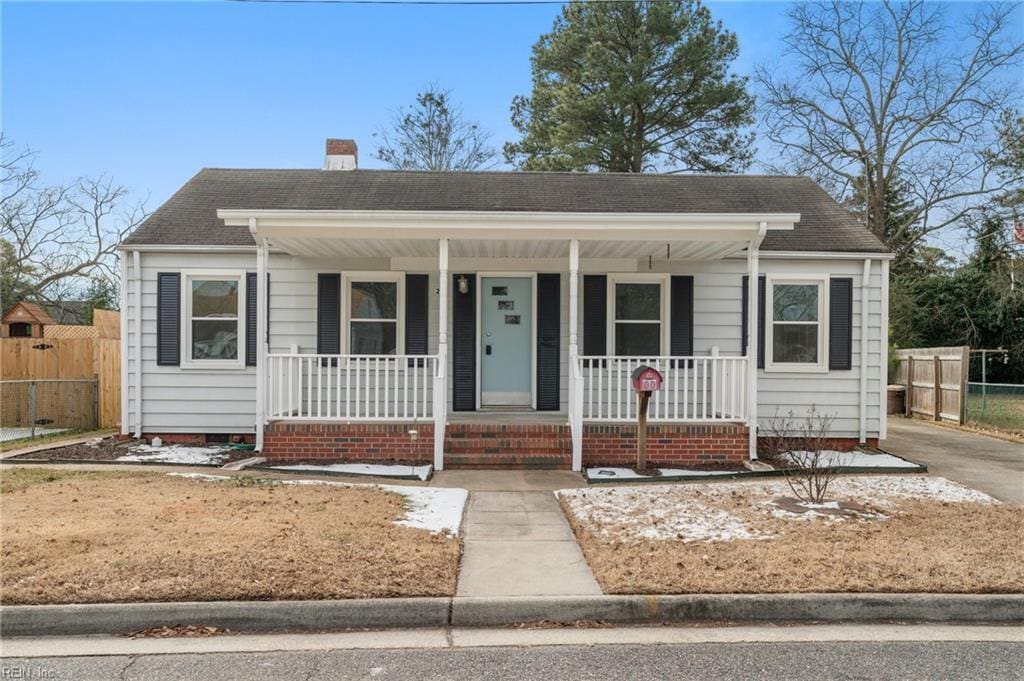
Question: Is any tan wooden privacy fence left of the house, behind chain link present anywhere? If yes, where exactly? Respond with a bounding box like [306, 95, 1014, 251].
[0, 338, 121, 428]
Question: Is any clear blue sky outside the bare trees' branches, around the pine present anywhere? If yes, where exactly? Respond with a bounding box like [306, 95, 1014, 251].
[0, 2, 785, 208]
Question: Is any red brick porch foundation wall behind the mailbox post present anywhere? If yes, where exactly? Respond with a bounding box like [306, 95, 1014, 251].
[583, 424, 749, 467]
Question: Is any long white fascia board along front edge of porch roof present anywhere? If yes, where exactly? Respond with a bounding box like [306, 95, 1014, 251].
[217, 209, 800, 239]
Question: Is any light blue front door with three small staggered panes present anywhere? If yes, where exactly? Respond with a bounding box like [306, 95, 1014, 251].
[480, 276, 534, 407]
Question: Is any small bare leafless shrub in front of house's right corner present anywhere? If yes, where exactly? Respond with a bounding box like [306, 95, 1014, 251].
[761, 406, 838, 504]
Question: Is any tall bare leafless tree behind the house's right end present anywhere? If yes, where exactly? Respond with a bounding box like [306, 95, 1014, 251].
[757, 0, 1024, 260]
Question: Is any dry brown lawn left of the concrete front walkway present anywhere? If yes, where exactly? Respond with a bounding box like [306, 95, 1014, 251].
[0, 468, 461, 604]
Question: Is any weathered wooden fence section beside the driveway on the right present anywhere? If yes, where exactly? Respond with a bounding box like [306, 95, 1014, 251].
[893, 345, 971, 423]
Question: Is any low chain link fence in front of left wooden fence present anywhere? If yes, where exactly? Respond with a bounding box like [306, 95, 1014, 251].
[0, 379, 99, 442]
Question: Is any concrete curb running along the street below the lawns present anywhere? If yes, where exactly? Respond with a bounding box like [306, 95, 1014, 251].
[0, 593, 1024, 636]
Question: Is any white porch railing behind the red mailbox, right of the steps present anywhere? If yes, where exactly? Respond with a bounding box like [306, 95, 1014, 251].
[570, 354, 746, 423]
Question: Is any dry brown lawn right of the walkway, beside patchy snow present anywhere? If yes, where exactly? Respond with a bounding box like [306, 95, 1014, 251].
[561, 477, 1024, 594]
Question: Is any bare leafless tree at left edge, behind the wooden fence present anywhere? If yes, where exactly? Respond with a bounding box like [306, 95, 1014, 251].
[0, 134, 146, 306]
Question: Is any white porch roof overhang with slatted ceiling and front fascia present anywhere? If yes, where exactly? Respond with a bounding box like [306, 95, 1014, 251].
[230, 210, 800, 260]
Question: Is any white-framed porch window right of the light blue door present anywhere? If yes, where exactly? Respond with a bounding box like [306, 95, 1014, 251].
[608, 274, 668, 356]
